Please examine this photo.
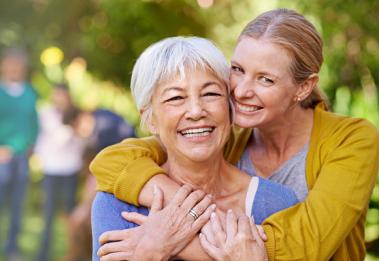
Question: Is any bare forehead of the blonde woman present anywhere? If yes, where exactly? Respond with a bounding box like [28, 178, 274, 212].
[232, 37, 292, 75]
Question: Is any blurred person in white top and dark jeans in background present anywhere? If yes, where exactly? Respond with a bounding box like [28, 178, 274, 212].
[35, 84, 86, 261]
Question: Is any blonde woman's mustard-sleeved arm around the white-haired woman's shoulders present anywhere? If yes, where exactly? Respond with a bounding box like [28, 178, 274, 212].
[90, 125, 251, 206]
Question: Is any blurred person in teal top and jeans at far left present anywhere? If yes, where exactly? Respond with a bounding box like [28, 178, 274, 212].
[0, 48, 38, 260]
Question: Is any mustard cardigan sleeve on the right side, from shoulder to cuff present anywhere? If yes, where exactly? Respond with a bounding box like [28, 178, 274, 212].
[263, 118, 379, 260]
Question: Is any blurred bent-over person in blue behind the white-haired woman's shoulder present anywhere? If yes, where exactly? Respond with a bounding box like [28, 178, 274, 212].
[64, 106, 135, 261]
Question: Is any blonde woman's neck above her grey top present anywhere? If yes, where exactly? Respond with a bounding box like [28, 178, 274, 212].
[254, 106, 313, 155]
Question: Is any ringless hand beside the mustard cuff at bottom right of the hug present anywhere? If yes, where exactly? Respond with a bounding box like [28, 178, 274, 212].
[200, 210, 266, 261]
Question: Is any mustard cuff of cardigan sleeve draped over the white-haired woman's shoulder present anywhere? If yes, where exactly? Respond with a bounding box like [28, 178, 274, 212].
[113, 157, 166, 206]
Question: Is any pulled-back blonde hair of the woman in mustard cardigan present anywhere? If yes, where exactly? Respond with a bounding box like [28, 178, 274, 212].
[239, 9, 327, 108]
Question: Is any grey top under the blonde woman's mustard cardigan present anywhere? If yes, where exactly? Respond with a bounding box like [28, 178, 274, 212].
[236, 144, 309, 201]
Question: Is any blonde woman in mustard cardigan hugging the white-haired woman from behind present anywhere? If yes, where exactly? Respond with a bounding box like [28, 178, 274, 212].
[92, 9, 379, 260]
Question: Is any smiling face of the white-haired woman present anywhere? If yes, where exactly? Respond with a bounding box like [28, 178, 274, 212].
[152, 70, 230, 161]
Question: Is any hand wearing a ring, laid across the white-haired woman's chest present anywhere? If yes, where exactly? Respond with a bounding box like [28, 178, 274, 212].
[98, 185, 215, 260]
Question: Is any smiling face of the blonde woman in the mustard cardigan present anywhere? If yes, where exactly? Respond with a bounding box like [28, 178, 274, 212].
[230, 37, 298, 128]
